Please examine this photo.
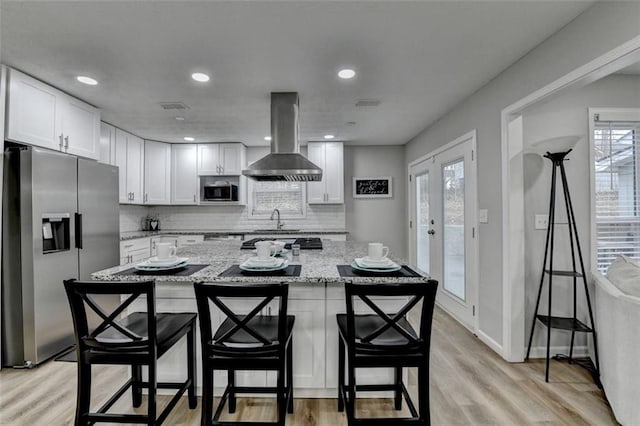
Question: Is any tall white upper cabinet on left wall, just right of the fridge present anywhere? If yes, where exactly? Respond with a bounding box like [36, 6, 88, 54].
[116, 129, 144, 204]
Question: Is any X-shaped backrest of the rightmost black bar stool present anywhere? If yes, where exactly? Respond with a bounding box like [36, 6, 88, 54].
[345, 280, 438, 355]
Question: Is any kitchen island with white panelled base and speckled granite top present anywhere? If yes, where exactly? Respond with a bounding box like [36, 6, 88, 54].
[93, 240, 428, 397]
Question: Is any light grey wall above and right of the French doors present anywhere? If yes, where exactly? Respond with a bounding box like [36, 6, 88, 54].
[405, 2, 640, 345]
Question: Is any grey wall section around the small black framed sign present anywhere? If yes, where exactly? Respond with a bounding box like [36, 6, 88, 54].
[344, 146, 407, 258]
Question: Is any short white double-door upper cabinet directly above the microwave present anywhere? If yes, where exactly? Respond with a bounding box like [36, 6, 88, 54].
[198, 143, 246, 176]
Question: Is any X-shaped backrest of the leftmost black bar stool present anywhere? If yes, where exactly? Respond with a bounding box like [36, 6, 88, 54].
[64, 280, 156, 357]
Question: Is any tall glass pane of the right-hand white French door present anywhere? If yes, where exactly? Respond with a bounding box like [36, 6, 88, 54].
[442, 159, 465, 300]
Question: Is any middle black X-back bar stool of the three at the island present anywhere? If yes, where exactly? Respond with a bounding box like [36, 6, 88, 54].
[194, 283, 295, 426]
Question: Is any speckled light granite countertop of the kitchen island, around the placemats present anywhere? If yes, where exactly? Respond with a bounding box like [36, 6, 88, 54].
[92, 240, 428, 285]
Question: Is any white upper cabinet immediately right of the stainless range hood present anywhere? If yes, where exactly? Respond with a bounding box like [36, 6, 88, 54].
[307, 142, 344, 204]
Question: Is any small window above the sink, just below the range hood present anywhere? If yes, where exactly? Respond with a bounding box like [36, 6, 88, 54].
[249, 179, 307, 219]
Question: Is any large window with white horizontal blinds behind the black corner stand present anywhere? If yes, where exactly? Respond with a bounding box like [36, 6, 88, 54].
[592, 110, 640, 271]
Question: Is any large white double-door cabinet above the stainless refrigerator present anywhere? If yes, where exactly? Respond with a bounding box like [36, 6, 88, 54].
[6, 69, 100, 159]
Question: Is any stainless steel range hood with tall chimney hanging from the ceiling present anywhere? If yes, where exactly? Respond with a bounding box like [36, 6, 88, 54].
[242, 92, 322, 182]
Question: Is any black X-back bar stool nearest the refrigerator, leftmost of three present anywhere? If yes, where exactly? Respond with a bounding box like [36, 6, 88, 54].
[64, 280, 197, 425]
